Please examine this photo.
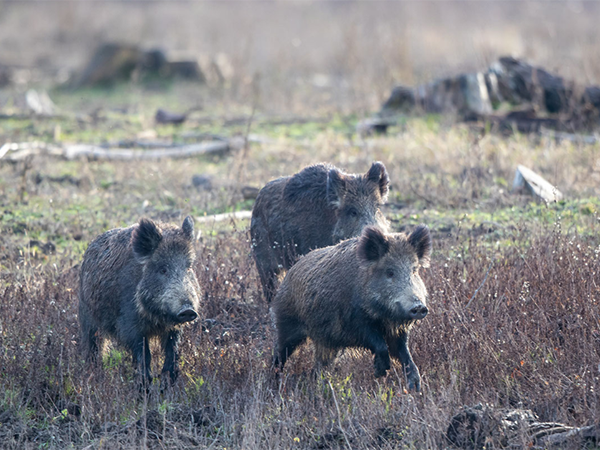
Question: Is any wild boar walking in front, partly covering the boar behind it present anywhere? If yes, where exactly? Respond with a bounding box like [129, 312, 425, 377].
[273, 225, 431, 391]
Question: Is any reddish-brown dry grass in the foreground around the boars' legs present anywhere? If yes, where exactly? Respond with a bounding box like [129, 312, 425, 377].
[0, 213, 600, 448]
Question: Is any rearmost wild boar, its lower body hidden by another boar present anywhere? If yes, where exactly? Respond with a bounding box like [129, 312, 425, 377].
[250, 162, 389, 302]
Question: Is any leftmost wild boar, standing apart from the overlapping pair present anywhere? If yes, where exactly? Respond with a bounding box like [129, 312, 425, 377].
[79, 217, 200, 382]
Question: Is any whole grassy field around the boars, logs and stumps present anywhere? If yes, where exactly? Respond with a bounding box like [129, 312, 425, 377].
[0, 1, 600, 450]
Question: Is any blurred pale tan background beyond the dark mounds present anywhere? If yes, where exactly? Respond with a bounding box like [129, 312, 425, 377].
[0, 0, 600, 113]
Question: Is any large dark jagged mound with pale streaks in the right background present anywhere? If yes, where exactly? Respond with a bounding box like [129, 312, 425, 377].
[378, 57, 600, 132]
